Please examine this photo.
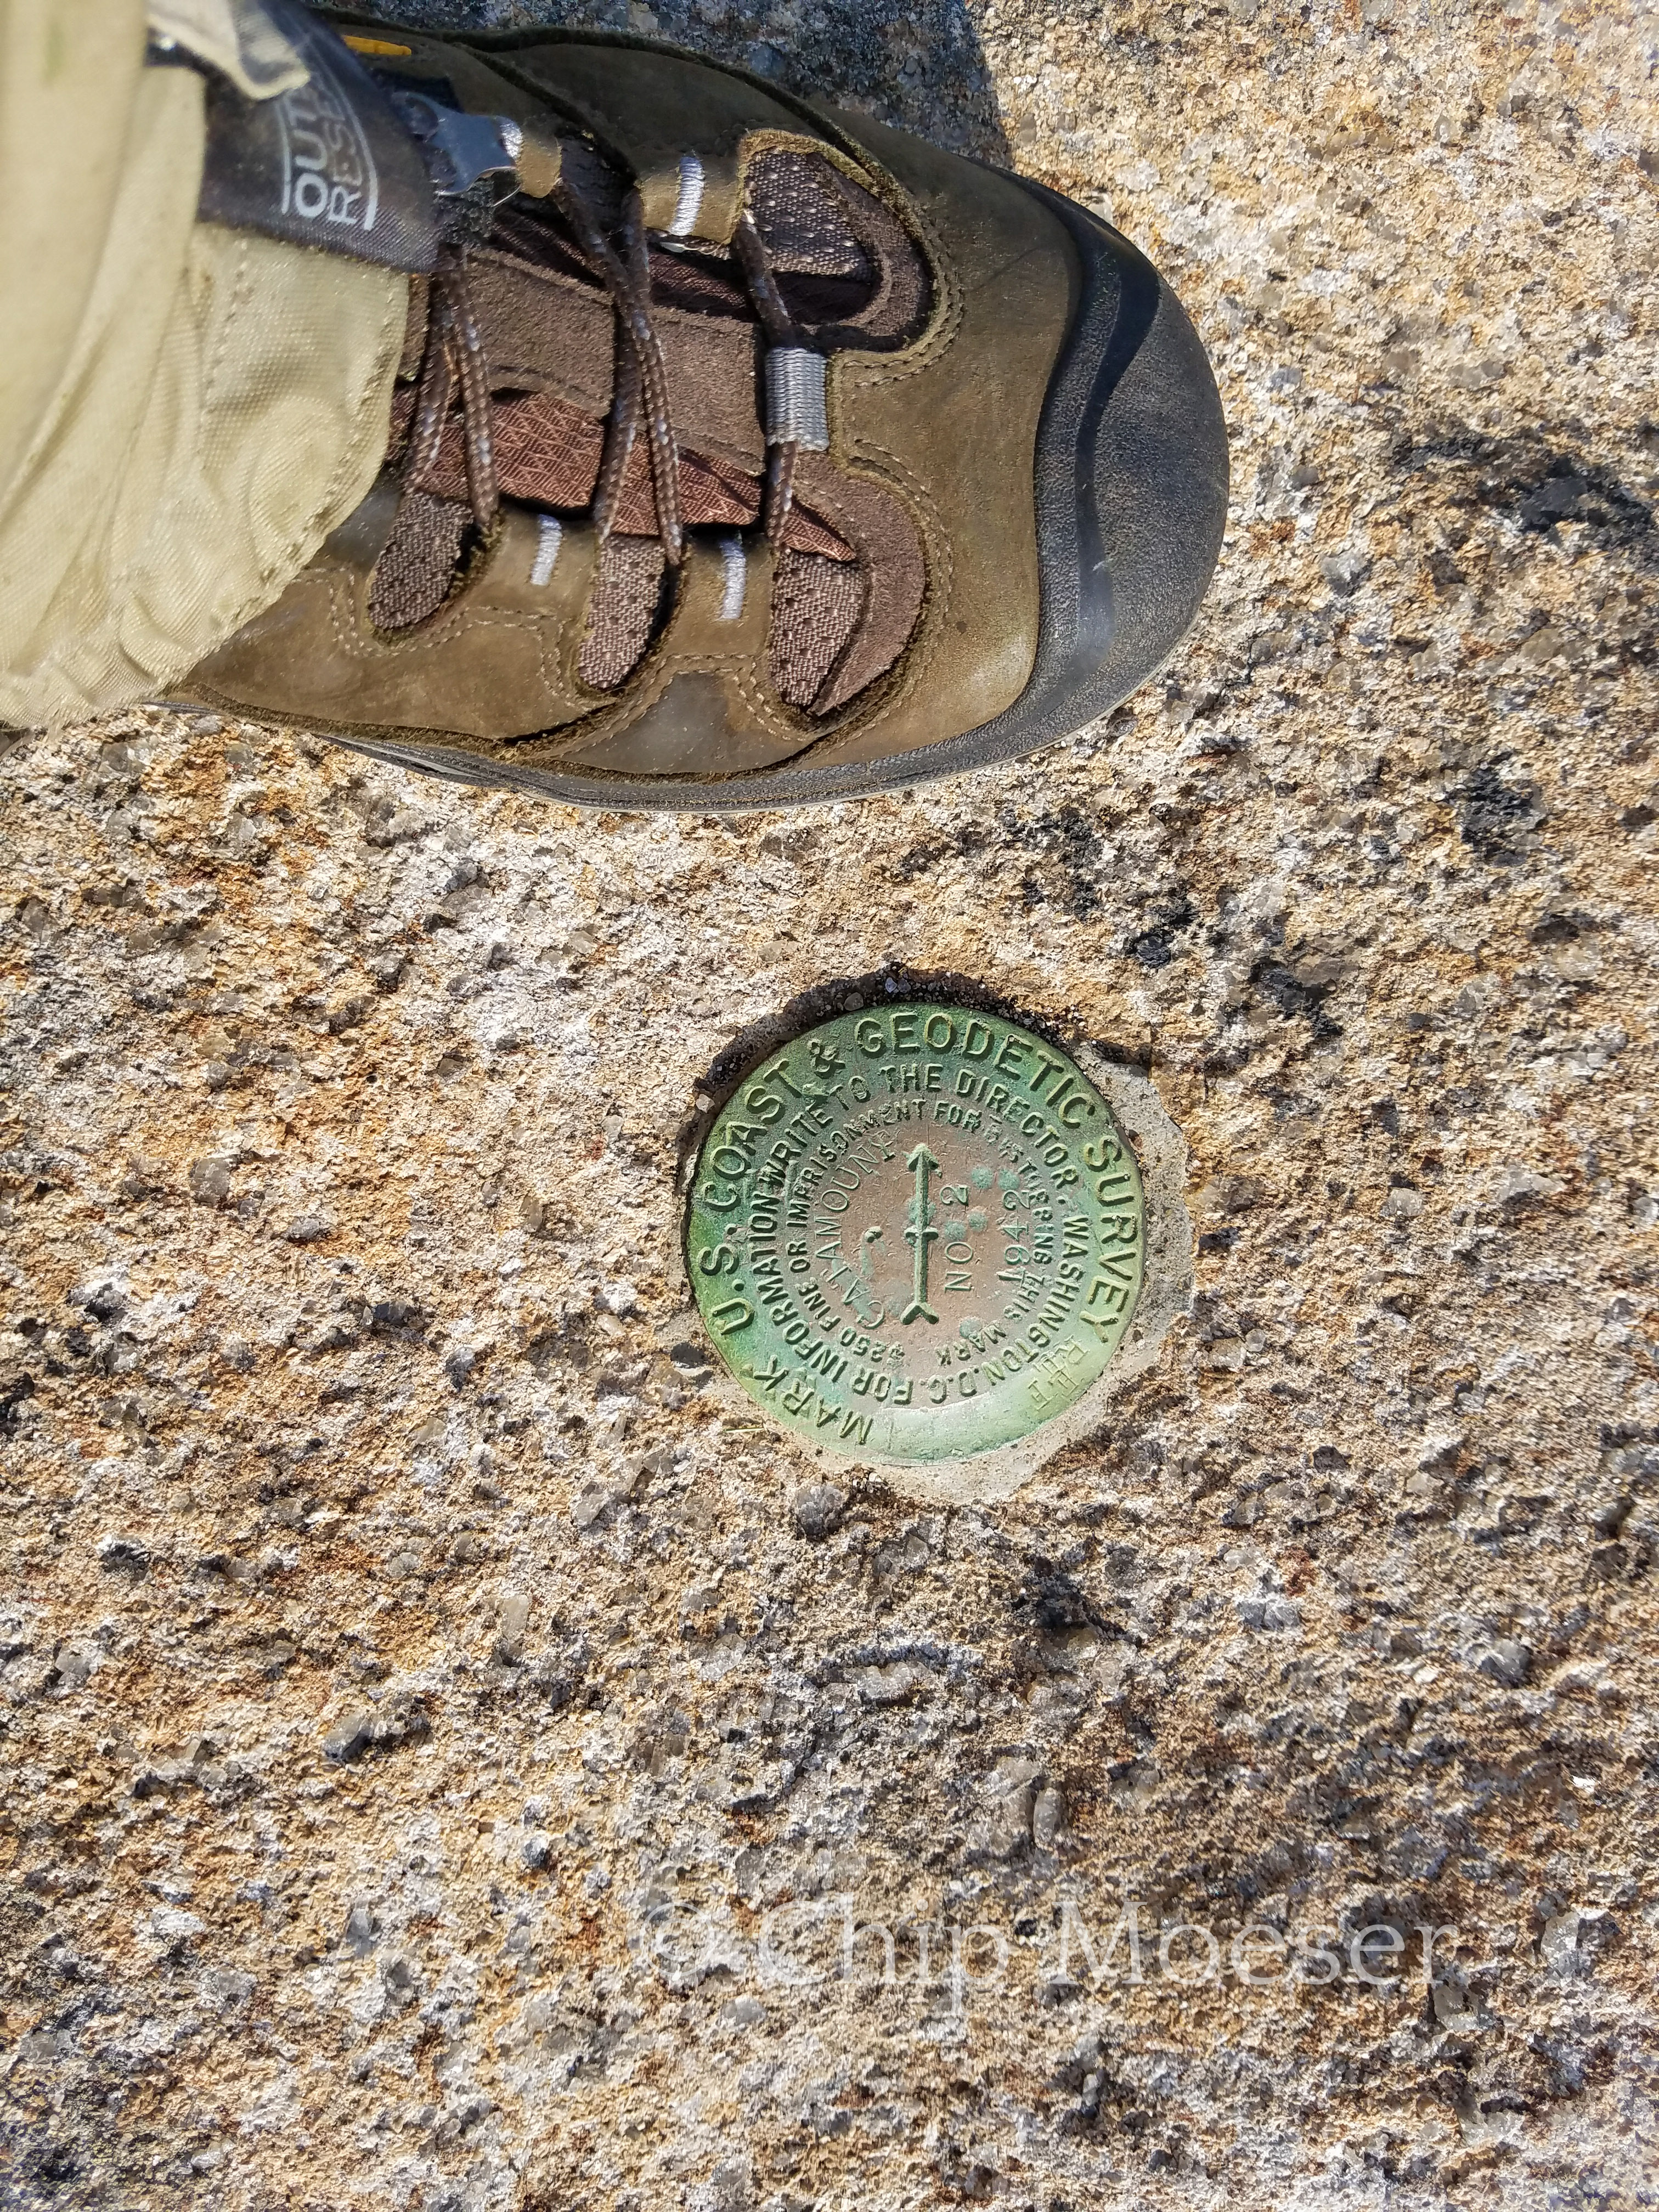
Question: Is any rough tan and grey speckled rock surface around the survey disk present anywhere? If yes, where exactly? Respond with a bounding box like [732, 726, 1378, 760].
[0, 0, 1659, 2212]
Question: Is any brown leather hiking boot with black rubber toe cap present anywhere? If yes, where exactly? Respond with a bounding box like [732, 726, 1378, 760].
[188, 18, 1228, 810]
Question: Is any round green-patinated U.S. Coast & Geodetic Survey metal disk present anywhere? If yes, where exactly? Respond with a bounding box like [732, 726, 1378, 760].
[686, 1005, 1146, 1462]
